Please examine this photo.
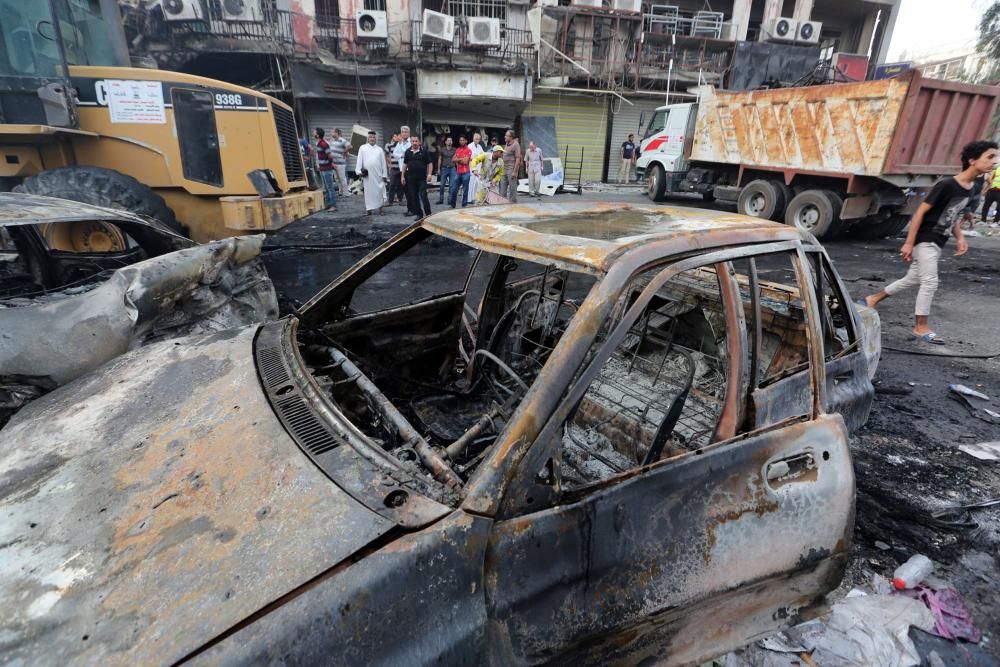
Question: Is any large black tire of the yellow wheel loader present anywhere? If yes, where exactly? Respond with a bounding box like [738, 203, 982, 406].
[14, 166, 185, 234]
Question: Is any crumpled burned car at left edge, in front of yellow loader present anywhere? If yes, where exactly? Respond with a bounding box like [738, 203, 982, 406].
[0, 193, 278, 425]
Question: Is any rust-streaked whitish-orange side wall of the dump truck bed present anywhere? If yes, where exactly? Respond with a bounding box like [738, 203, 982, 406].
[691, 78, 909, 176]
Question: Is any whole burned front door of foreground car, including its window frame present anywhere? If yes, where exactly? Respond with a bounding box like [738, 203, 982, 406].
[486, 244, 854, 664]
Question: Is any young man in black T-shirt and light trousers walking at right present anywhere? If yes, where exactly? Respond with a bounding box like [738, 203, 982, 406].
[865, 141, 997, 345]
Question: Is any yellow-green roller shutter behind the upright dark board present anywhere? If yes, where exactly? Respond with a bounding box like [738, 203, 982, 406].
[521, 93, 608, 182]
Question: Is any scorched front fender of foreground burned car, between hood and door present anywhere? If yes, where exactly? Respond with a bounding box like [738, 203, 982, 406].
[193, 512, 490, 666]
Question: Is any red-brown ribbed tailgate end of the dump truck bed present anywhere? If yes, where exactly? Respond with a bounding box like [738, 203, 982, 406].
[883, 71, 1000, 175]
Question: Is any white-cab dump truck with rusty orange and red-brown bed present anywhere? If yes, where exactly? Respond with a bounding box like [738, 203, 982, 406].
[636, 71, 1000, 238]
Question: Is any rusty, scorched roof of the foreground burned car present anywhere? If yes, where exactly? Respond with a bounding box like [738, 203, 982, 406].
[421, 202, 805, 274]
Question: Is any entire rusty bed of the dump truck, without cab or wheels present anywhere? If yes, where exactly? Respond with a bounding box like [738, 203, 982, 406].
[691, 71, 1000, 177]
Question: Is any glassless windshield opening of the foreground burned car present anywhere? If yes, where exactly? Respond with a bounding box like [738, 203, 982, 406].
[299, 236, 596, 486]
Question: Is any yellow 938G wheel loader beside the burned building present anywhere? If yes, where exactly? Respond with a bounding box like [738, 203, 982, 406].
[0, 0, 323, 252]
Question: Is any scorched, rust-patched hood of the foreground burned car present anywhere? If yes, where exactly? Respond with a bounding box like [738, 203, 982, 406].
[0, 327, 394, 664]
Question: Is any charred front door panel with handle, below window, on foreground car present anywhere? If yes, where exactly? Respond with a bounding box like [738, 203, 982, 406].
[486, 417, 854, 665]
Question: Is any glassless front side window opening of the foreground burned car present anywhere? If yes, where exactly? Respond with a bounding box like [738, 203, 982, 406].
[561, 267, 729, 491]
